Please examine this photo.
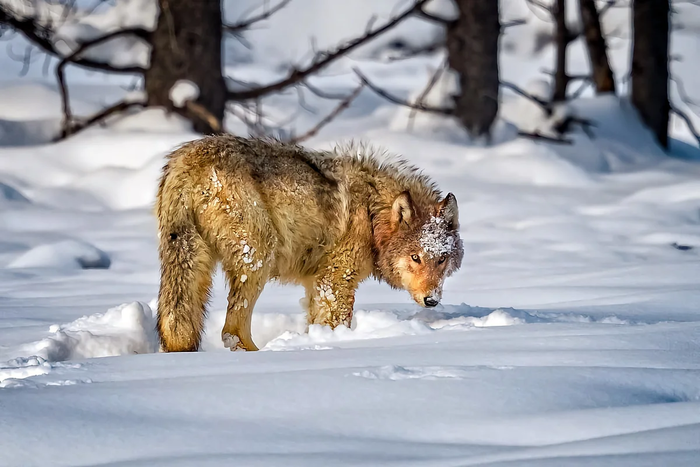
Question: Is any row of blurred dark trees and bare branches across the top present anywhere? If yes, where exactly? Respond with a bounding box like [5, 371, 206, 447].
[0, 0, 697, 147]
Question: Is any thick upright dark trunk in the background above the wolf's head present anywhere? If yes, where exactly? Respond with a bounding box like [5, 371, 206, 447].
[447, 0, 501, 137]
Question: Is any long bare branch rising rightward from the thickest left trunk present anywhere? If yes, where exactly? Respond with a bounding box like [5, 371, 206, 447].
[228, 0, 429, 101]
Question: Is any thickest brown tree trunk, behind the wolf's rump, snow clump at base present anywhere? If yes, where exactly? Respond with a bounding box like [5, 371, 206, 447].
[144, 0, 226, 133]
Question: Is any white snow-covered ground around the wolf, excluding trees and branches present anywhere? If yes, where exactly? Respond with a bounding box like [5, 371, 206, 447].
[0, 0, 700, 467]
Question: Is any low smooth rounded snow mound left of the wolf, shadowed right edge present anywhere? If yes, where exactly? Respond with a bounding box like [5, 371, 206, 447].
[7, 240, 111, 269]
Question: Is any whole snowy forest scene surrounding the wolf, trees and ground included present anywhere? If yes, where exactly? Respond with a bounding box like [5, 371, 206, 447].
[0, 0, 700, 466]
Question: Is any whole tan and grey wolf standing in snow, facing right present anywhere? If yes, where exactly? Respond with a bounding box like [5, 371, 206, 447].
[156, 135, 463, 352]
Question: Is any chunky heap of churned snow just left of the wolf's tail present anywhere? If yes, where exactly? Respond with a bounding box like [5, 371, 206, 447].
[23, 302, 158, 362]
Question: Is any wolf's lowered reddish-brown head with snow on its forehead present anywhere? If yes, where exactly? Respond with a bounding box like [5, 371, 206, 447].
[377, 192, 464, 307]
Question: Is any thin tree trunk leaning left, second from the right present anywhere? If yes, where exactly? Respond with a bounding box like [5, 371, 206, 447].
[579, 0, 615, 94]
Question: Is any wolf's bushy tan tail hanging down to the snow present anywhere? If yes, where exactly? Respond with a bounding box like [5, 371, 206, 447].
[156, 157, 215, 352]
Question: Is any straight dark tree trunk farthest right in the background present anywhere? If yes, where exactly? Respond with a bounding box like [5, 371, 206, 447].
[632, 0, 670, 148]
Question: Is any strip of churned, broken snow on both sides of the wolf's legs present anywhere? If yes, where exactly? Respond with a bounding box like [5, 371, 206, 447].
[5, 302, 540, 364]
